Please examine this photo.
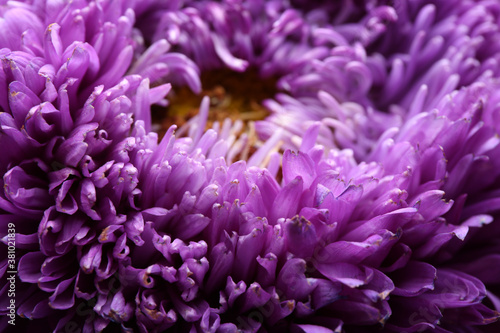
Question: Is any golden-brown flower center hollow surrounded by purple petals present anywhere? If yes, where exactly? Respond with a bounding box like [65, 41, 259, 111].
[152, 68, 277, 136]
